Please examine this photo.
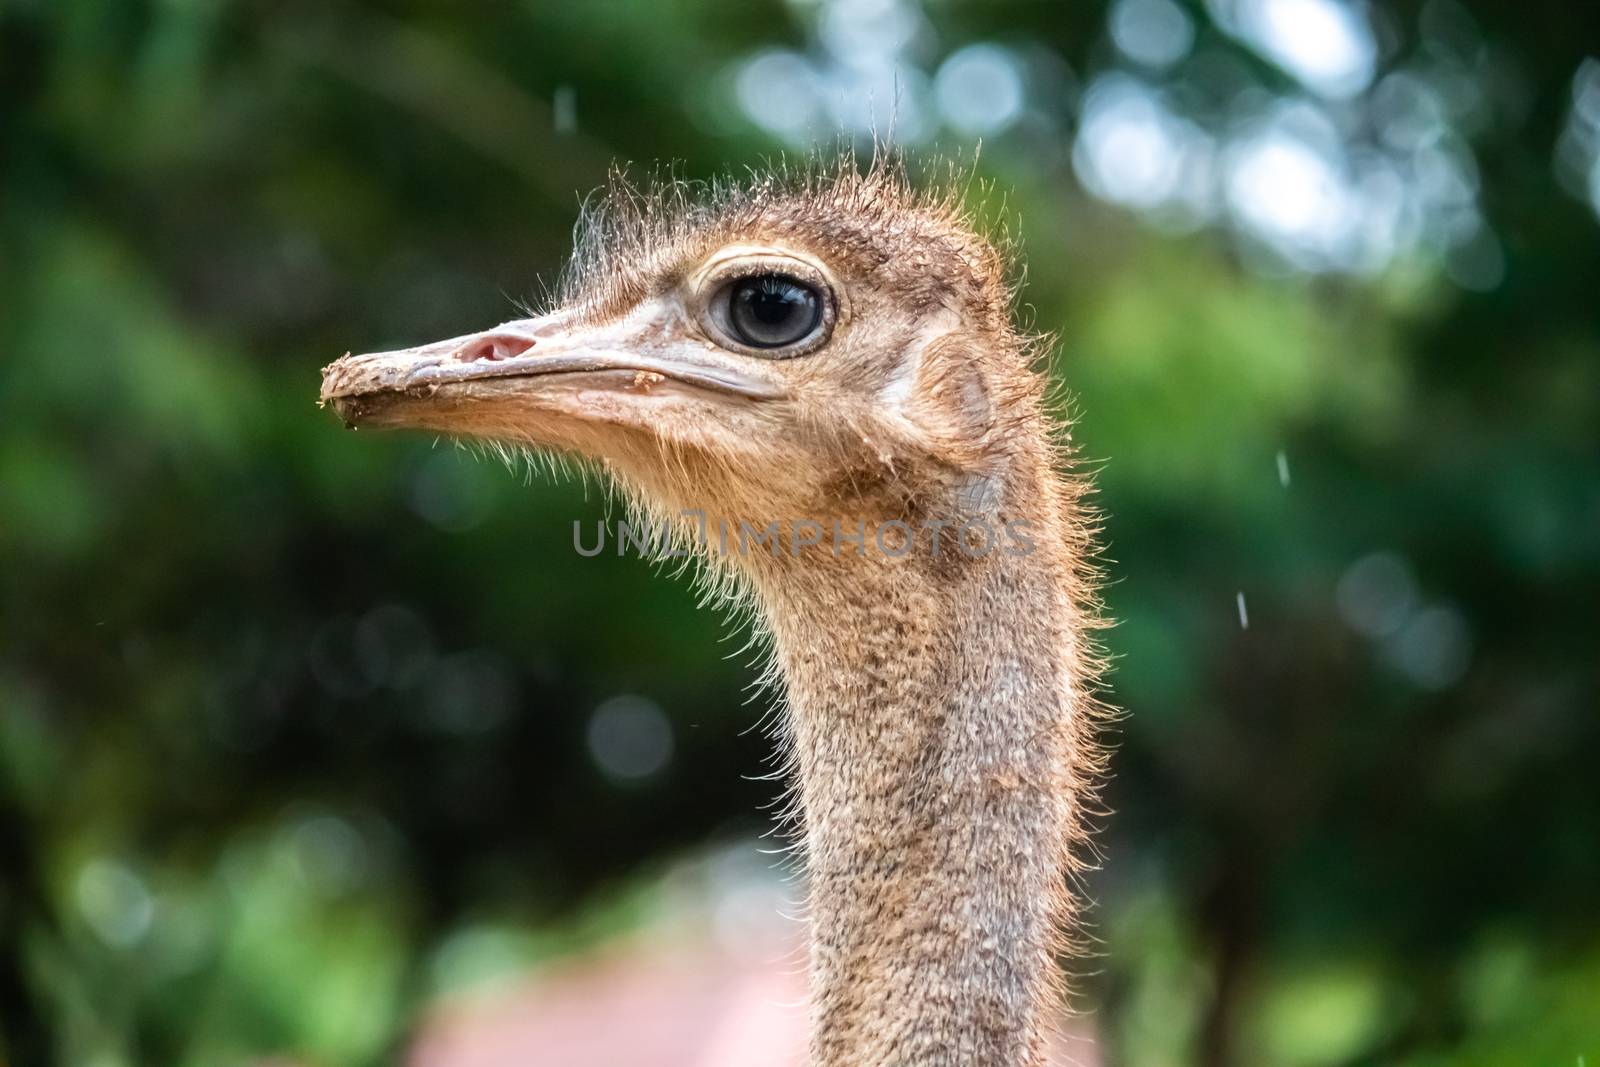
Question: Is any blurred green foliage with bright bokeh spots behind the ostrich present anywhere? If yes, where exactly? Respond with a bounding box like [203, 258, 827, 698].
[0, 0, 1600, 1067]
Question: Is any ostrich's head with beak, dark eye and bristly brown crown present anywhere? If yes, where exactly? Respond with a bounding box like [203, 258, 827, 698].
[322, 165, 1037, 556]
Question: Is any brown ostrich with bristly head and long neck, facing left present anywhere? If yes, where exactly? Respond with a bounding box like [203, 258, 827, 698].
[322, 160, 1101, 1067]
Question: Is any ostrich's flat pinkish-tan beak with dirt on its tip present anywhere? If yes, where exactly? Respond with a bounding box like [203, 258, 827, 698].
[320, 312, 787, 430]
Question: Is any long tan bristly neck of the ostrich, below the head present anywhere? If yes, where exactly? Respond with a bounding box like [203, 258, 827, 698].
[755, 502, 1080, 1067]
